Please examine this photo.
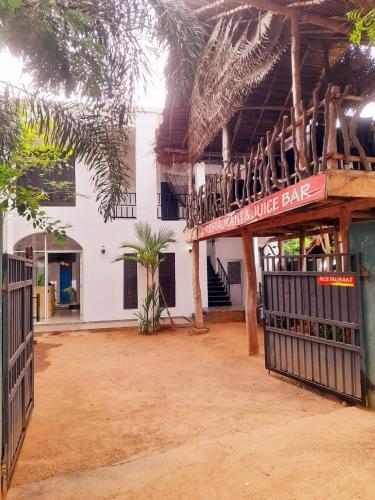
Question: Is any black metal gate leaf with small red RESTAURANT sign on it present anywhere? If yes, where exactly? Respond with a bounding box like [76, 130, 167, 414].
[261, 254, 366, 404]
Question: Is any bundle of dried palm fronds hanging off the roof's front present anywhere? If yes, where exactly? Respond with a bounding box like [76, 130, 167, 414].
[189, 12, 286, 161]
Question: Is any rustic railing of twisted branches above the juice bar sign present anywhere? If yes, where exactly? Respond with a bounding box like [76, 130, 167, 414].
[187, 85, 375, 228]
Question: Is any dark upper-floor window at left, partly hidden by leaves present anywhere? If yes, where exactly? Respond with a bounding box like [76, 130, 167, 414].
[21, 160, 76, 207]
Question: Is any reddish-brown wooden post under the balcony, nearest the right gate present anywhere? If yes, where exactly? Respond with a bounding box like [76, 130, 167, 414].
[242, 231, 259, 356]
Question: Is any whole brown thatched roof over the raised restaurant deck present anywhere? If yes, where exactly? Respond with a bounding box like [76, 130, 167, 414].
[156, 0, 375, 168]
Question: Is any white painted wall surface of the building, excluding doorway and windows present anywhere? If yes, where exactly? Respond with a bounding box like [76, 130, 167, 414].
[5, 112, 208, 321]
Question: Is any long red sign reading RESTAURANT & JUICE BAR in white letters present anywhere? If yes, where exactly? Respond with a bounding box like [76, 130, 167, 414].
[199, 173, 327, 239]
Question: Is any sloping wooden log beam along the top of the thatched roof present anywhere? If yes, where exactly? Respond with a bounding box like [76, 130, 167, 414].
[242, 0, 350, 36]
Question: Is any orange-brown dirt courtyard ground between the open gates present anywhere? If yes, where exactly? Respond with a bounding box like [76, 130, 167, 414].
[9, 323, 375, 500]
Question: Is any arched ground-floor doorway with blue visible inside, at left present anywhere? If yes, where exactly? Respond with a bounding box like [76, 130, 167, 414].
[14, 233, 83, 325]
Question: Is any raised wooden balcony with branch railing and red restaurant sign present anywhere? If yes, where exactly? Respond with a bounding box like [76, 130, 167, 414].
[187, 85, 375, 239]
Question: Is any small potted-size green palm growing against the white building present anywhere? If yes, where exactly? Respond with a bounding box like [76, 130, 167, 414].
[116, 221, 176, 333]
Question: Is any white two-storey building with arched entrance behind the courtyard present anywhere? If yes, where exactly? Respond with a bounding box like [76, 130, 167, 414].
[4, 111, 266, 325]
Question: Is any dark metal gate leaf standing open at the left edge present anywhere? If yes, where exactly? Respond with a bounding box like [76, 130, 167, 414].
[2, 254, 34, 490]
